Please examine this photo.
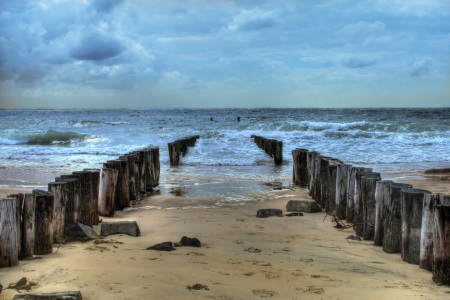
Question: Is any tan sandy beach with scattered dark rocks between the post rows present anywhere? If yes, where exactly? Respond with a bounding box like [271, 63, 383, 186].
[0, 172, 450, 299]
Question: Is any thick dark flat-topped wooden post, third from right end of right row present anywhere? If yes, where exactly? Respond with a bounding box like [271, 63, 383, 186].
[400, 188, 430, 265]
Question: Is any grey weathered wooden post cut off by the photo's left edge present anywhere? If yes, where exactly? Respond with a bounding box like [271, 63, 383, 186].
[0, 198, 19, 268]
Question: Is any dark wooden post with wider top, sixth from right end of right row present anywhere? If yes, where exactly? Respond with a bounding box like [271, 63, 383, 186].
[361, 173, 381, 241]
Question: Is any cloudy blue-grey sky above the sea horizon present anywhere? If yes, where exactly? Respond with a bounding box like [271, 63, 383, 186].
[0, 0, 450, 108]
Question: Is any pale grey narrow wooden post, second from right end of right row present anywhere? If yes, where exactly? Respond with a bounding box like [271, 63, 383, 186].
[419, 194, 450, 271]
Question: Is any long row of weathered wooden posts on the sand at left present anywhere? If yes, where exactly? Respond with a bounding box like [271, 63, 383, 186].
[0, 148, 160, 267]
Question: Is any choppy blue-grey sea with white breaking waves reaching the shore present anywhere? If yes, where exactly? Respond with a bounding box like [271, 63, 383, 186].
[0, 108, 450, 202]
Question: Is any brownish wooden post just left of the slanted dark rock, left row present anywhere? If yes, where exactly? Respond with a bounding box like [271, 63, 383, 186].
[48, 182, 68, 244]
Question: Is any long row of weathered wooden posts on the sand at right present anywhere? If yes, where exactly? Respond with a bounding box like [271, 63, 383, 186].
[292, 149, 450, 285]
